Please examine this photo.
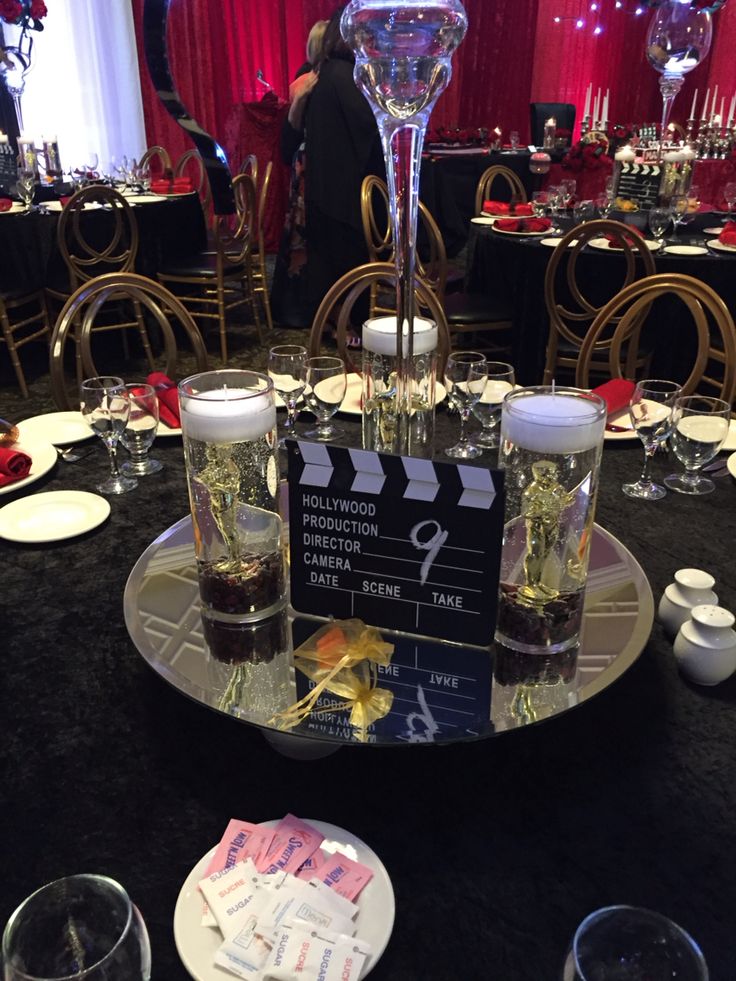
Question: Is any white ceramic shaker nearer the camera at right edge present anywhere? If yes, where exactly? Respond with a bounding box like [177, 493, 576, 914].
[674, 605, 736, 685]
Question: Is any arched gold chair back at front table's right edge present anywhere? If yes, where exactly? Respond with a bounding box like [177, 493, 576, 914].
[575, 273, 736, 408]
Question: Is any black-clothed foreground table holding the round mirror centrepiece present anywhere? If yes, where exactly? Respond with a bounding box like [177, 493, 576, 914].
[0, 403, 736, 981]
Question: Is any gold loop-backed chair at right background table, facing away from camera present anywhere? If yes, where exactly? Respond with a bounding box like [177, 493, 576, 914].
[543, 219, 656, 385]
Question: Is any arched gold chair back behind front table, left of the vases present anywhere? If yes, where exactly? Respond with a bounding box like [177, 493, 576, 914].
[50, 272, 208, 410]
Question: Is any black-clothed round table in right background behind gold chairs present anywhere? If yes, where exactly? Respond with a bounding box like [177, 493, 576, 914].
[466, 212, 736, 385]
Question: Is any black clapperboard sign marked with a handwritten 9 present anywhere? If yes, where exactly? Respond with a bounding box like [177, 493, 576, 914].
[287, 440, 504, 647]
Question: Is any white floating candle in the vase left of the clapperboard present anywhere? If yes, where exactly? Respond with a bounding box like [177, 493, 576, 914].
[179, 387, 276, 443]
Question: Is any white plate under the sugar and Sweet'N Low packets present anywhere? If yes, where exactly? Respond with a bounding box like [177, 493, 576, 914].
[174, 818, 396, 981]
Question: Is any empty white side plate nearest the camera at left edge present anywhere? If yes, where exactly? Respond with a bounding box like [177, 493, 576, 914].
[0, 491, 110, 543]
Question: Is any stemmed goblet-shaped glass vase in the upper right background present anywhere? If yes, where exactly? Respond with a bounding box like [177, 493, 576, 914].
[646, 0, 713, 139]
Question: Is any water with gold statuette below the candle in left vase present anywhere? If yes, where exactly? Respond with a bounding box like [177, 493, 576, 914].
[184, 431, 286, 621]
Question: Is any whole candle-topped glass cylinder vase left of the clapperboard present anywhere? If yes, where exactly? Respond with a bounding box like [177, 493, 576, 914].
[179, 370, 286, 624]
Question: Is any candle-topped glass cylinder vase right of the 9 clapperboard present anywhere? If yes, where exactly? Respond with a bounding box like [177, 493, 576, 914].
[496, 386, 606, 655]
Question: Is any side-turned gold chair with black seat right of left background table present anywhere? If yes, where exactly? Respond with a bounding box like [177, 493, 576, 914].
[158, 174, 263, 364]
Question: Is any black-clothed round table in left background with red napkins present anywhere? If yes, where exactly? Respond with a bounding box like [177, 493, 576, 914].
[0, 193, 207, 292]
